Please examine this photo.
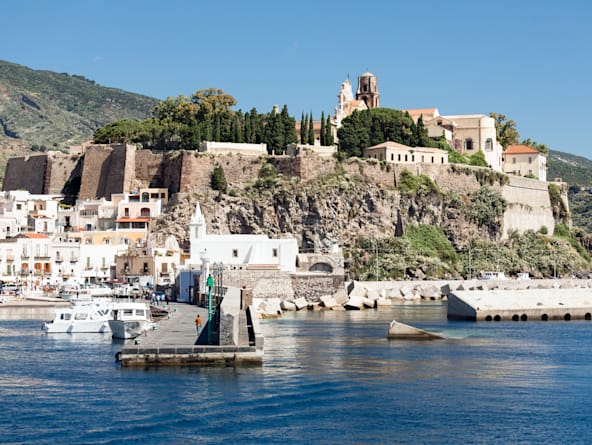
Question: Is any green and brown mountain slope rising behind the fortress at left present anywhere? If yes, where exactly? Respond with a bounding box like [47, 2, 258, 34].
[0, 61, 158, 176]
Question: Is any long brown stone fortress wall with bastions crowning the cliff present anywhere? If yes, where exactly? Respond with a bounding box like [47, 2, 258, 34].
[3, 144, 567, 236]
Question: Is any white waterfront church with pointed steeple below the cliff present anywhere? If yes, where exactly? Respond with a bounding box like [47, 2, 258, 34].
[179, 203, 298, 301]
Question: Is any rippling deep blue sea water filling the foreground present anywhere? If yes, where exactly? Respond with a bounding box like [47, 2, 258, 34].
[0, 302, 592, 444]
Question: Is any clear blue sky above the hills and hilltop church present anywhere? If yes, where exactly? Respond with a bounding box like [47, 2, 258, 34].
[0, 0, 592, 158]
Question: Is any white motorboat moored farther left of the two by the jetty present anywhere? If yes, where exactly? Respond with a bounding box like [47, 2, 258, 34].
[41, 298, 113, 333]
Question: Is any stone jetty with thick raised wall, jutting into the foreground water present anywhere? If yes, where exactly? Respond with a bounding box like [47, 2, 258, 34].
[116, 288, 264, 367]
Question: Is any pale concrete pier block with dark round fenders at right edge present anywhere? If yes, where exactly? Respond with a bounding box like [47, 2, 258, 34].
[448, 288, 592, 321]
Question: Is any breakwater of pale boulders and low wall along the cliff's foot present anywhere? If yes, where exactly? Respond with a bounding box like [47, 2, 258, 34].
[253, 279, 592, 318]
